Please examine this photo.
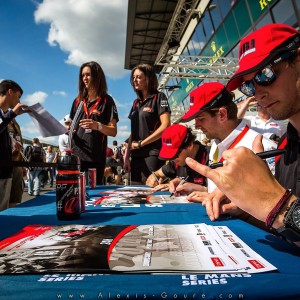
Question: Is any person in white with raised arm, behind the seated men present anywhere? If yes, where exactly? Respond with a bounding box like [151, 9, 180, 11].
[238, 96, 286, 141]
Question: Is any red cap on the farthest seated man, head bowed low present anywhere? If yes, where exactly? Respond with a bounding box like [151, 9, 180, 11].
[159, 124, 188, 159]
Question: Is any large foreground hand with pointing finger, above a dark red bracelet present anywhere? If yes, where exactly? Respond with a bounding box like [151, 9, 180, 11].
[186, 147, 285, 221]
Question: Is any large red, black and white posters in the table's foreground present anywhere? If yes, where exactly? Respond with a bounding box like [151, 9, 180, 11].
[0, 224, 276, 274]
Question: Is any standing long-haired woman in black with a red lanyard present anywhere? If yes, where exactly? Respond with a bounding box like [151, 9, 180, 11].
[70, 61, 119, 185]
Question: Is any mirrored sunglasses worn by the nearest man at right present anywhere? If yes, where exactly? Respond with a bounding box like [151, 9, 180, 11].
[238, 50, 297, 97]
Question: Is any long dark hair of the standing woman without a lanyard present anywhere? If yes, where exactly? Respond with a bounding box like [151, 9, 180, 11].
[130, 64, 158, 99]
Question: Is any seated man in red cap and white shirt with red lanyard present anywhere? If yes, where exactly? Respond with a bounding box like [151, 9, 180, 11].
[181, 82, 277, 195]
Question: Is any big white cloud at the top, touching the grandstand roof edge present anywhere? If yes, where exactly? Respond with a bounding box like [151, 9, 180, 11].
[34, 0, 127, 78]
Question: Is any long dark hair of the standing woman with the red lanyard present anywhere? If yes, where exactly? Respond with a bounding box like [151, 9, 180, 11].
[78, 61, 107, 100]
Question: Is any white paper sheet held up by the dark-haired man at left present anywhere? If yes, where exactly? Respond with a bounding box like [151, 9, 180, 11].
[29, 103, 66, 137]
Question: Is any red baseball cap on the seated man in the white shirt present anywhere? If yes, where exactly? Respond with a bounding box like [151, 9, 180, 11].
[180, 82, 233, 122]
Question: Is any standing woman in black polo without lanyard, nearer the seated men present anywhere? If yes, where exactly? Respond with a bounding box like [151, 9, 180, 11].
[124, 64, 171, 184]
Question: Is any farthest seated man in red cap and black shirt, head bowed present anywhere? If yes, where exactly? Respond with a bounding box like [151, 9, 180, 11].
[149, 124, 207, 191]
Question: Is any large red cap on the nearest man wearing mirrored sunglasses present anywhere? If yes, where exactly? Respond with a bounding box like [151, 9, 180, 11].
[227, 24, 300, 91]
